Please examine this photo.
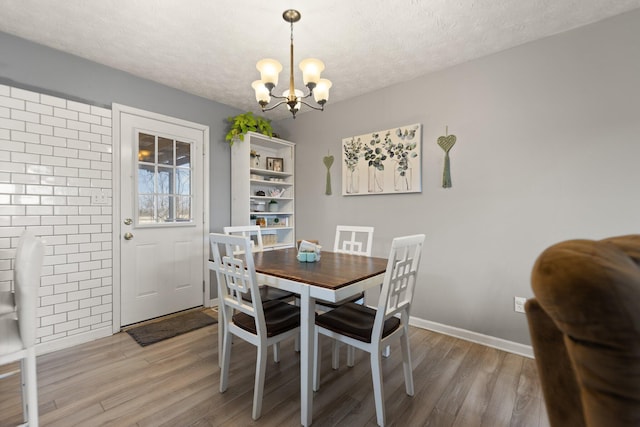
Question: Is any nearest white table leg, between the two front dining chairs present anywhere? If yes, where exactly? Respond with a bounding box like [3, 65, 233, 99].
[300, 286, 316, 427]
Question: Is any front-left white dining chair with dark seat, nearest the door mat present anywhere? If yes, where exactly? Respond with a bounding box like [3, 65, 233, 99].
[209, 233, 300, 420]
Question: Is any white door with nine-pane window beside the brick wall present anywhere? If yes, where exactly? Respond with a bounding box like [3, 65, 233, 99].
[114, 105, 208, 326]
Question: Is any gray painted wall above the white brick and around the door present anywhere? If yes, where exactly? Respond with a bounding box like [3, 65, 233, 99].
[0, 33, 239, 236]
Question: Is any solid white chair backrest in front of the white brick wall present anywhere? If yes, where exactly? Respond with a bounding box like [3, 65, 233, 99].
[13, 230, 44, 348]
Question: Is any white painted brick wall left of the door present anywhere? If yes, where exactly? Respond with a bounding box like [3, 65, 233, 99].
[0, 85, 113, 342]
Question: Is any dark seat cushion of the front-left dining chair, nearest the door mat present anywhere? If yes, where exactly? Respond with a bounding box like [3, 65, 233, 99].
[233, 301, 300, 337]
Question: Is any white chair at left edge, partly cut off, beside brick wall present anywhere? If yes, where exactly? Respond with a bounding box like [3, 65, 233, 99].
[0, 230, 44, 427]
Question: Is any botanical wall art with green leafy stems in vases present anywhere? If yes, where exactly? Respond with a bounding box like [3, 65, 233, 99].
[342, 124, 422, 196]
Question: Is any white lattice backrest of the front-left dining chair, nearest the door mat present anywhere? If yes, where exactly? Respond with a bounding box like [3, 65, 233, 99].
[209, 233, 267, 337]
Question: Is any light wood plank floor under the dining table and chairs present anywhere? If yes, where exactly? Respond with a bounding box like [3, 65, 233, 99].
[0, 310, 548, 427]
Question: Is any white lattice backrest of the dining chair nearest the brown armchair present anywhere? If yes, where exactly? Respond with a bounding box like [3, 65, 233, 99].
[371, 234, 425, 342]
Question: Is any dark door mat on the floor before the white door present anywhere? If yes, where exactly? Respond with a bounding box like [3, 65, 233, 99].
[126, 311, 218, 347]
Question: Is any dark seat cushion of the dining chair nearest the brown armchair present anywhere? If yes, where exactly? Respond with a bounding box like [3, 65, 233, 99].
[316, 302, 400, 343]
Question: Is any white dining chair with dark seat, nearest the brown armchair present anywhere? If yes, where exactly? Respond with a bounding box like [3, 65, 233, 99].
[313, 234, 425, 426]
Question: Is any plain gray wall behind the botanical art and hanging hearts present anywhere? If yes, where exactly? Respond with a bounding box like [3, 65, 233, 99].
[274, 11, 640, 344]
